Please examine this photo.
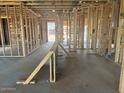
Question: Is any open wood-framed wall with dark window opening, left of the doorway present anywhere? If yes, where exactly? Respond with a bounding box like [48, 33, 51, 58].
[0, 4, 42, 57]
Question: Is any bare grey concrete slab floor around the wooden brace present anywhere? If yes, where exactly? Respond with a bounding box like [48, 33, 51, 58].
[0, 46, 120, 93]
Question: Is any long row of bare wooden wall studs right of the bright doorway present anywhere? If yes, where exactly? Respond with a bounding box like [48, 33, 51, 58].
[58, 2, 118, 55]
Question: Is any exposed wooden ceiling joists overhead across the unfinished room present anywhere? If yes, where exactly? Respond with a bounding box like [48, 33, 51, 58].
[0, 0, 108, 15]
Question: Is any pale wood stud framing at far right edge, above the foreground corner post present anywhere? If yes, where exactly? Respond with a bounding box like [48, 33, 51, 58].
[115, 0, 124, 64]
